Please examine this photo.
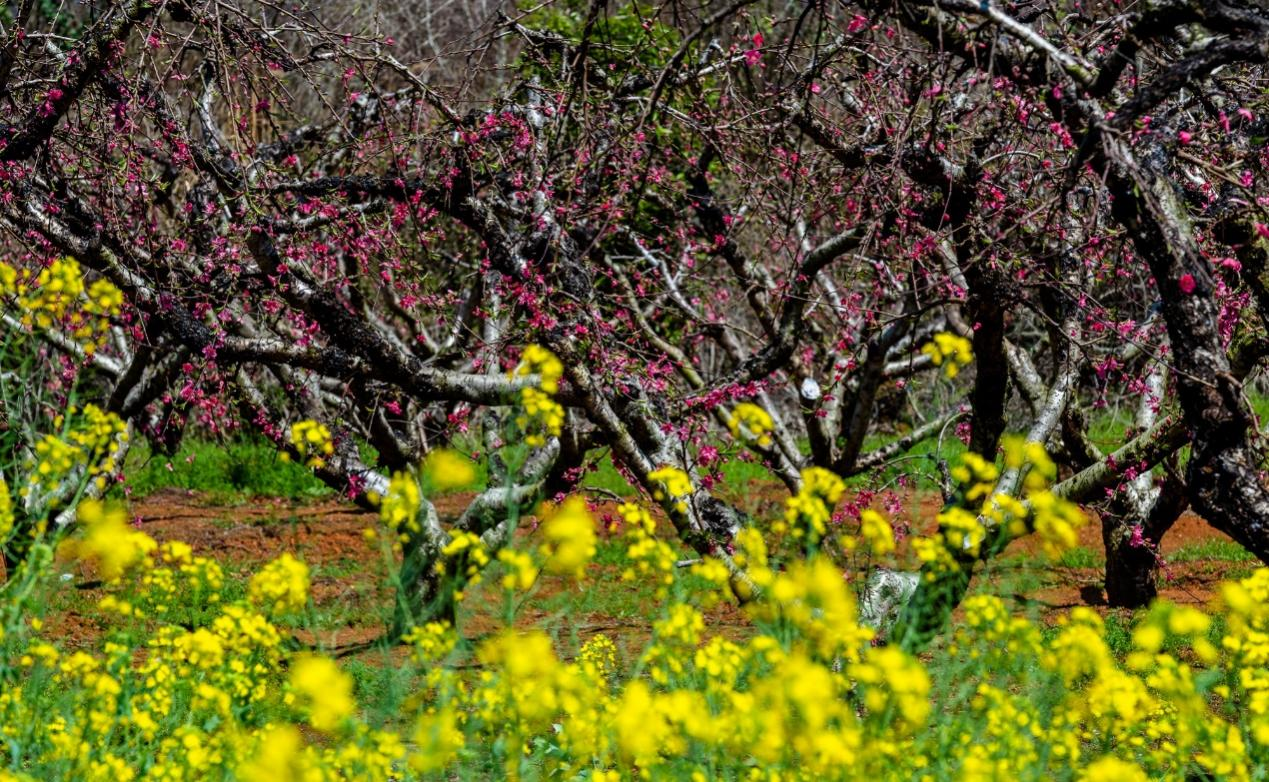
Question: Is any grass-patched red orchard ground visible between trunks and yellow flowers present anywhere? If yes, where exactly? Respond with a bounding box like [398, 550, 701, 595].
[42, 452, 1256, 670]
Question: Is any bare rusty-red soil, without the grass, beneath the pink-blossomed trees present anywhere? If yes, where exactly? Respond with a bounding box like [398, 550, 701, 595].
[34, 485, 1253, 659]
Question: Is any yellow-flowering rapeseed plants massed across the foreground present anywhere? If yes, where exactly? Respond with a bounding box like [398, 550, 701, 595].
[0, 340, 1269, 782]
